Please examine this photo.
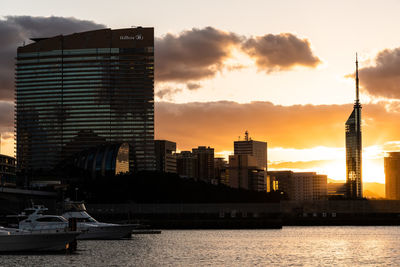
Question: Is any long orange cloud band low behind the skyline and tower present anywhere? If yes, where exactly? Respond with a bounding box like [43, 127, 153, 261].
[155, 101, 400, 151]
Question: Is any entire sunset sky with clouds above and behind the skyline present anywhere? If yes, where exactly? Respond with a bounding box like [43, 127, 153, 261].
[0, 0, 400, 183]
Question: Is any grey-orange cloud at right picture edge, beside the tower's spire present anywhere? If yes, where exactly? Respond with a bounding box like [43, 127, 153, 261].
[359, 48, 400, 99]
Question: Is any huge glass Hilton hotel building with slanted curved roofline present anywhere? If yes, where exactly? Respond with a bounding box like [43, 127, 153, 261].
[15, 27, 155, 174]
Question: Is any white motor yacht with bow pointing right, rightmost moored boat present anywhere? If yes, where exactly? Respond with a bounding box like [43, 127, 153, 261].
[62, 201, 139, 240]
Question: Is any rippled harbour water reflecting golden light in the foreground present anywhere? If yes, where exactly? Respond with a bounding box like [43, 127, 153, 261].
[0, 227, 400, 266]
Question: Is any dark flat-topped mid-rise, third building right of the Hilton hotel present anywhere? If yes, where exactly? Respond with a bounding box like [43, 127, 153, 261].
[192, 146, 214, 183]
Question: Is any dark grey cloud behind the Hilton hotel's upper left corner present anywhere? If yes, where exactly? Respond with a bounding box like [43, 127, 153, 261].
[0, 16, 105, 100]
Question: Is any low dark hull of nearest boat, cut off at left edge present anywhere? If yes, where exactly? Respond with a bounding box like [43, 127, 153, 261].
[0, 227, 80, 253]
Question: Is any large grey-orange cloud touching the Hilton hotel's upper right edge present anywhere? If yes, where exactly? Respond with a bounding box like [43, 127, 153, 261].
[155, 27, 241, 82]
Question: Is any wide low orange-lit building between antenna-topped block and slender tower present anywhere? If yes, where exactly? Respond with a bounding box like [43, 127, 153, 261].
[268, 171, 328, 201]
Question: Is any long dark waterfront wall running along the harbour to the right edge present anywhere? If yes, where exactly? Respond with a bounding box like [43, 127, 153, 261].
[87, 200, 400, 229]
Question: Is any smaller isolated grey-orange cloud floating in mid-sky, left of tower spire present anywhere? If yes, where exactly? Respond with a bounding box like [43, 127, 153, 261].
[243, 33, 321, 72]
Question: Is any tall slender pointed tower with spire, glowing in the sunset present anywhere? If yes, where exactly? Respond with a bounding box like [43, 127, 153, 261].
[345, 55, 362, 199]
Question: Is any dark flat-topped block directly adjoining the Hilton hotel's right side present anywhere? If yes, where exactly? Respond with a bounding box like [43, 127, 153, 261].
[154, 140, 176, 173]
